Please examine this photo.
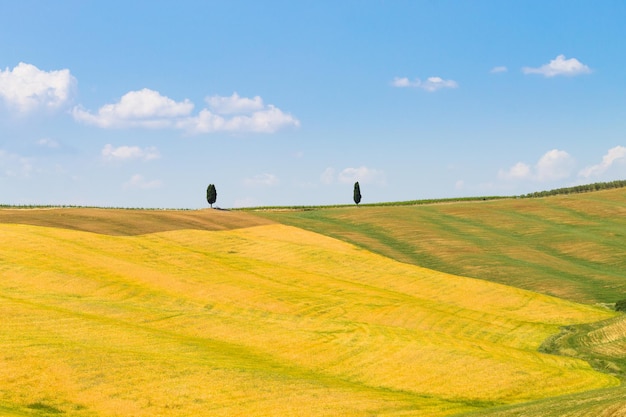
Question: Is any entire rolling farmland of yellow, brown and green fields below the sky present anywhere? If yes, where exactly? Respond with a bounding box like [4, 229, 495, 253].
[0, 191, 626, 417]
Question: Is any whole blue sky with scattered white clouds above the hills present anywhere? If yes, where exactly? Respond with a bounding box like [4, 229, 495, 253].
[0, 0, 626, 208]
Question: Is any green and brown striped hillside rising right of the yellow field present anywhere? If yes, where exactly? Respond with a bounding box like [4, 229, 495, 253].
[251, 188, 626, 303]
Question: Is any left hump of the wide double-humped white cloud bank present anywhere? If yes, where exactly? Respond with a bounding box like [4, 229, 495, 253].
[72, 88, 193, 128]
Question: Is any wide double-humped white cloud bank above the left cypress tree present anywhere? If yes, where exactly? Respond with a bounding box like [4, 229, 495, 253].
[72, 88, 300, 134]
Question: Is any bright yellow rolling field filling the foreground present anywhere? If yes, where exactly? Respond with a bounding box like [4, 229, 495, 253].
[0, 213, 619, 416]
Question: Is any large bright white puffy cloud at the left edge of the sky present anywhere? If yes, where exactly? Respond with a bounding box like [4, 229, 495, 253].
[0, 62, 76, 113]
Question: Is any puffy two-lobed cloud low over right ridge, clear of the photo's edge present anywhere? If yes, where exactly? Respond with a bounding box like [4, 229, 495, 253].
[498, 149, 575, 182]
